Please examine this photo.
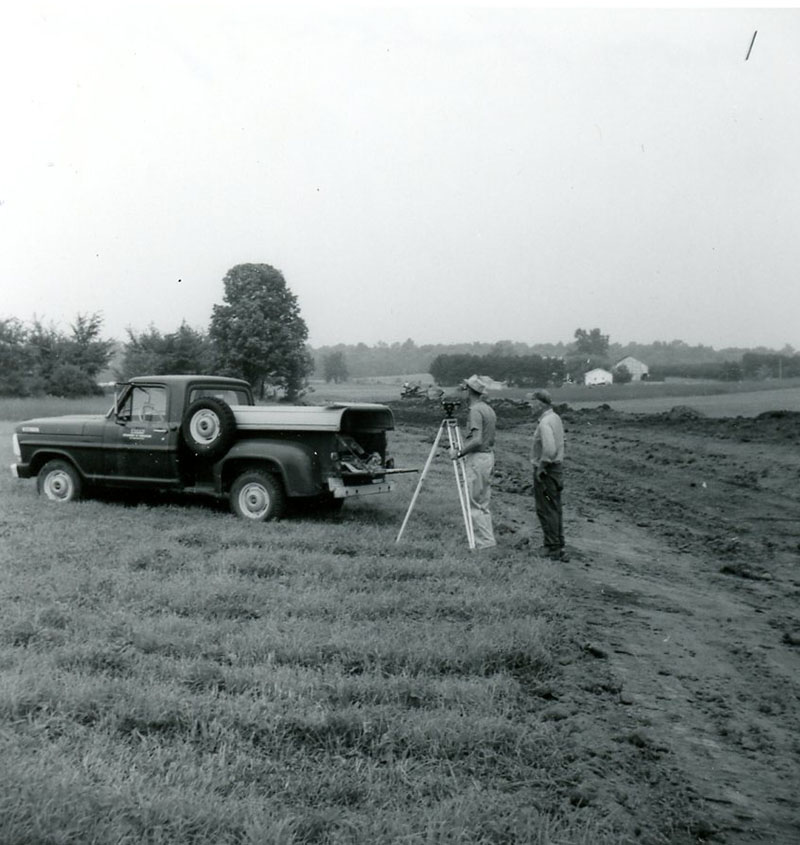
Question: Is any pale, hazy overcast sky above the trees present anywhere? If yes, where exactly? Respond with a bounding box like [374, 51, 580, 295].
[0, 0, 800, 349]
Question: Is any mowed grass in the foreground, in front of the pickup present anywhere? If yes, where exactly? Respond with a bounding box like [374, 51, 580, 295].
[0, 425, 616, 845]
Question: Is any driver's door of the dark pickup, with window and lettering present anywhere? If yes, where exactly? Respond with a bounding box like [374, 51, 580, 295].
[104, 384, 179, 486]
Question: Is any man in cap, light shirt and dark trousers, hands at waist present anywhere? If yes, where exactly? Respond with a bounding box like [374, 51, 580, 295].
[527, 390, 569, 561]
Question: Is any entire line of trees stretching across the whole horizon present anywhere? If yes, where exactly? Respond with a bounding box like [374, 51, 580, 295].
[0, 276, 800, 398]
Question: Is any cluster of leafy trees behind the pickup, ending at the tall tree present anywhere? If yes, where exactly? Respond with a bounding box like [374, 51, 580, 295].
[0, 264, 313, 398]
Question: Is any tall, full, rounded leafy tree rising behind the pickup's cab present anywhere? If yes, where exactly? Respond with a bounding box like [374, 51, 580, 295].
[209, 264, 313, 399]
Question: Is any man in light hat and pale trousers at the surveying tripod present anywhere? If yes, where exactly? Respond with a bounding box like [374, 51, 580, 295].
[450, 375, 497, 549]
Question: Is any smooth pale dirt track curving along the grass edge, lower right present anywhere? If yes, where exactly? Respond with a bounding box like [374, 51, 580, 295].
[564, 522, 800, 843]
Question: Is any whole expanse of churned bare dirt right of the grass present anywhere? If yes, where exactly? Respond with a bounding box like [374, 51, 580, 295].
[488, 406, 800, 845]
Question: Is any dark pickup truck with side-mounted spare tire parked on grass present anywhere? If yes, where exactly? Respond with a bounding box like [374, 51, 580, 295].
[11, 375, 402, 522]
